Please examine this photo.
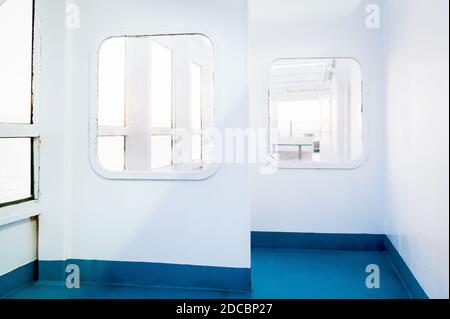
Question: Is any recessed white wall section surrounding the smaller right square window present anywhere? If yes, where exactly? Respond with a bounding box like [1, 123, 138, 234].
[249, 0, 385, 233]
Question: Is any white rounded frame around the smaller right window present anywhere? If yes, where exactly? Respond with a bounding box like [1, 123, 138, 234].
[267, 57, 369, 170]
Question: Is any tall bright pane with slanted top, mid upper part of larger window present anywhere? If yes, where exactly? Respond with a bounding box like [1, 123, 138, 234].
[150, 40, 172, 128]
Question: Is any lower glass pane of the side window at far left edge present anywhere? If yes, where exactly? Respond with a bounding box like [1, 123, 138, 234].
[0, 138, 32, 204]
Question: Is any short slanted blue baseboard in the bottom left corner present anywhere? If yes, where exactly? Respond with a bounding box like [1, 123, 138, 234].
[0, 262, 37, 298]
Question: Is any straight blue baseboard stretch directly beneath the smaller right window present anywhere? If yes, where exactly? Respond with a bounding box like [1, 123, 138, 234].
[252, 232, 386, 251]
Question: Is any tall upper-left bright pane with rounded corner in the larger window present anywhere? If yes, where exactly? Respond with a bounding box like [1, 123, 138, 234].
[98, 38, 125, 126]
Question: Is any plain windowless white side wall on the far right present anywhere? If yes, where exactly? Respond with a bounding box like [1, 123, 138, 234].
[384, 0, 449, 298]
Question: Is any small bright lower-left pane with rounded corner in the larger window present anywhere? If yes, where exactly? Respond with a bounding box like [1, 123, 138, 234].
[98, 136, 125, 172]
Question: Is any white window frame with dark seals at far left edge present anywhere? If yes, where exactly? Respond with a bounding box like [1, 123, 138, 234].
[0, 0, 40, 212]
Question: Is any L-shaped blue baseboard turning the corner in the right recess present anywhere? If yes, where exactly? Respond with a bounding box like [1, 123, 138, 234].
[252, 232, 428, 299]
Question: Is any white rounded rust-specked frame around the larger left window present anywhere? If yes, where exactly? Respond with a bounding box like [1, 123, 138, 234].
[89, 34, 221, 181]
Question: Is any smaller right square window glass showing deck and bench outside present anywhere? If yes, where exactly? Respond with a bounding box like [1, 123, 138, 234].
[269, 58, 365, 168]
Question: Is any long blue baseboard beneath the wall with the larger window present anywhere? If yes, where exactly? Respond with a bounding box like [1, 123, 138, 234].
[39, 260, 251, 291]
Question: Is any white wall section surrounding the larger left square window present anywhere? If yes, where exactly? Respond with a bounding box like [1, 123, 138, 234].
[39, 0, 250, 268]
